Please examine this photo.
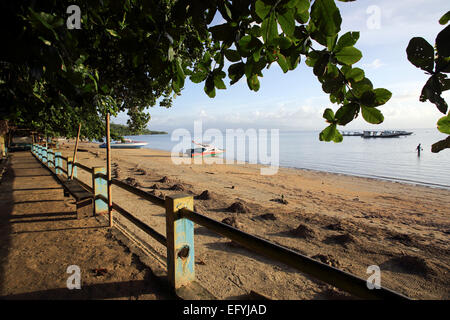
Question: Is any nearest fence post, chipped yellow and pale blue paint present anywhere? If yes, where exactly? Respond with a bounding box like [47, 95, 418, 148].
[166, 194, 195, 289]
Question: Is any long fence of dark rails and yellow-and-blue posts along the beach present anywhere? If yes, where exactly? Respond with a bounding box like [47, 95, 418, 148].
[31, 144, 408, 300]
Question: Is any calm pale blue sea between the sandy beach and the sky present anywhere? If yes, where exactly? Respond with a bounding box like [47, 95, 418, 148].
[125, 129, 450, 189]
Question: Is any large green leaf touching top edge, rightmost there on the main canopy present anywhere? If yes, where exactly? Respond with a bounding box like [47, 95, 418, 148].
[311, 0, 342, 37]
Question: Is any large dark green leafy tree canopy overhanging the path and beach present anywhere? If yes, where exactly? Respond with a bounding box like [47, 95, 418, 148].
[0, 0, 398, 142]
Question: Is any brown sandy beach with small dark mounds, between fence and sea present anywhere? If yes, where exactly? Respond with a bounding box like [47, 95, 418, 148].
[57, 143, 450, 299]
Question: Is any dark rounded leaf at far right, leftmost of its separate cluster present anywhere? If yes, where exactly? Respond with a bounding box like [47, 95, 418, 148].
[406, 37, 434, 72]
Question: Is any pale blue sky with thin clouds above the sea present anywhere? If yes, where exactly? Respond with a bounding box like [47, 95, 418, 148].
[112, 0, 450, 132]
